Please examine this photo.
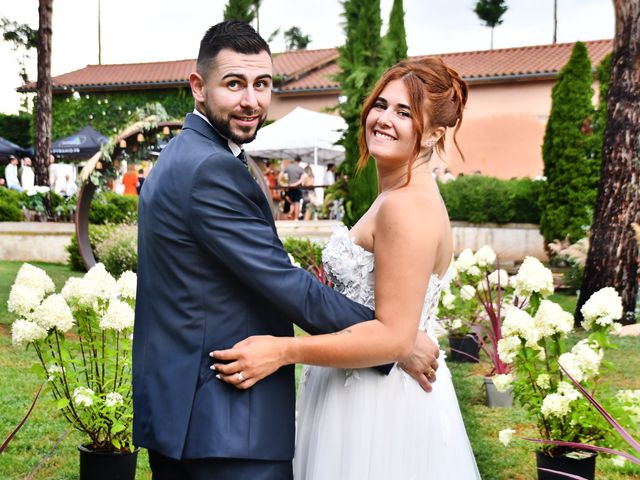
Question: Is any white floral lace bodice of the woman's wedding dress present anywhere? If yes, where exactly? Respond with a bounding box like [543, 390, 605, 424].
[322, 226, 442, 342]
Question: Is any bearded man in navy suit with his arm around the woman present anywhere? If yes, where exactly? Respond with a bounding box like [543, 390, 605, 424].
[133, 21, 437, 480]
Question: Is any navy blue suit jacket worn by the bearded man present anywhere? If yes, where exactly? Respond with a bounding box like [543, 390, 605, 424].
[133, 114, 388, 460]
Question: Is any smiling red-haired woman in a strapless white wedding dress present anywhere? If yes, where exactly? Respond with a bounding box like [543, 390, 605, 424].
[213, 58, 480, 480]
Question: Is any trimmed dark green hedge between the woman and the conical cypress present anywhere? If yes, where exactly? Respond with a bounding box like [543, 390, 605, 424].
[440, 175, 541, 223]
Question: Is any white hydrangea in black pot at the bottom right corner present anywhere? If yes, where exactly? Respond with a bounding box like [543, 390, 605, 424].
[498, 258, 622, 479]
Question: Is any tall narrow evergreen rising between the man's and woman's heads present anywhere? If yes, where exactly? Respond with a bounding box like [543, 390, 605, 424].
[338, 0, 382, 226]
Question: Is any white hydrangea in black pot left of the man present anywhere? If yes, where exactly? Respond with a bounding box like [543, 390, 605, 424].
[7, 264, 137, 480]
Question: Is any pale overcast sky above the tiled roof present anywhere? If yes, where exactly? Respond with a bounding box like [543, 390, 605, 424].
[0, 0, 614, 113]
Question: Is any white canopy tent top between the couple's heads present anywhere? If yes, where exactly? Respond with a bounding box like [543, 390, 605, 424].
[244, 107, 347, 166]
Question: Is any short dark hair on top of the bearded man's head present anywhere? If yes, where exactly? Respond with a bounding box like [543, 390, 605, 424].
[196, 20, 271, 78]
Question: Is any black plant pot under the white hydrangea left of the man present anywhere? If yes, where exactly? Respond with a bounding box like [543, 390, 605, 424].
[78, 445, 140, 480]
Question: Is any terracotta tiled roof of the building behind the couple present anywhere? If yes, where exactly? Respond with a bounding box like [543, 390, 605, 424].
[19, 40, 613, 92]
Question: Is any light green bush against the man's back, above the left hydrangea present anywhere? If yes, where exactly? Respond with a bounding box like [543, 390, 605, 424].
[96, 225, 138, 276]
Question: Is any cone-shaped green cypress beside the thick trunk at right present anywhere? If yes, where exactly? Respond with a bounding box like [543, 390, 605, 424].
[540, 42, 600, 242]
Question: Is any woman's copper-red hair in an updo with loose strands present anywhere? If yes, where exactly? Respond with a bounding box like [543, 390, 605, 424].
[358, 57, 467, 185]
